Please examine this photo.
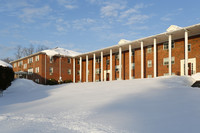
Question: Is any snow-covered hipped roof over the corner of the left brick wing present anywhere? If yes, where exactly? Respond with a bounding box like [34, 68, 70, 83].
[41, 47, 81, 57]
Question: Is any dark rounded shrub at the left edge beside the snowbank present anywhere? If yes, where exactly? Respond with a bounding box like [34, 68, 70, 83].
[0, 66, 14, 92]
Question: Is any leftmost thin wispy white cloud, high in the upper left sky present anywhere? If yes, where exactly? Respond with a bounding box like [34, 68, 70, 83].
[19, 6, 52, 22]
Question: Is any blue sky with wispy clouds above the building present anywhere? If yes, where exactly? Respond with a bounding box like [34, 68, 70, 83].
[0, 0, 200, 58]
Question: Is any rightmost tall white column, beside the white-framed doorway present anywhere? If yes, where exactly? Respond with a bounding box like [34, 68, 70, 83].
[185, 31, 188, 76]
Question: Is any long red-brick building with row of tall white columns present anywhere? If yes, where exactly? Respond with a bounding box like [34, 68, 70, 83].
[12, 24, 200, 84]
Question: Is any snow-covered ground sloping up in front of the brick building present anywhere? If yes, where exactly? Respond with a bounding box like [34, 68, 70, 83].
[0, 76, 200, 133]
